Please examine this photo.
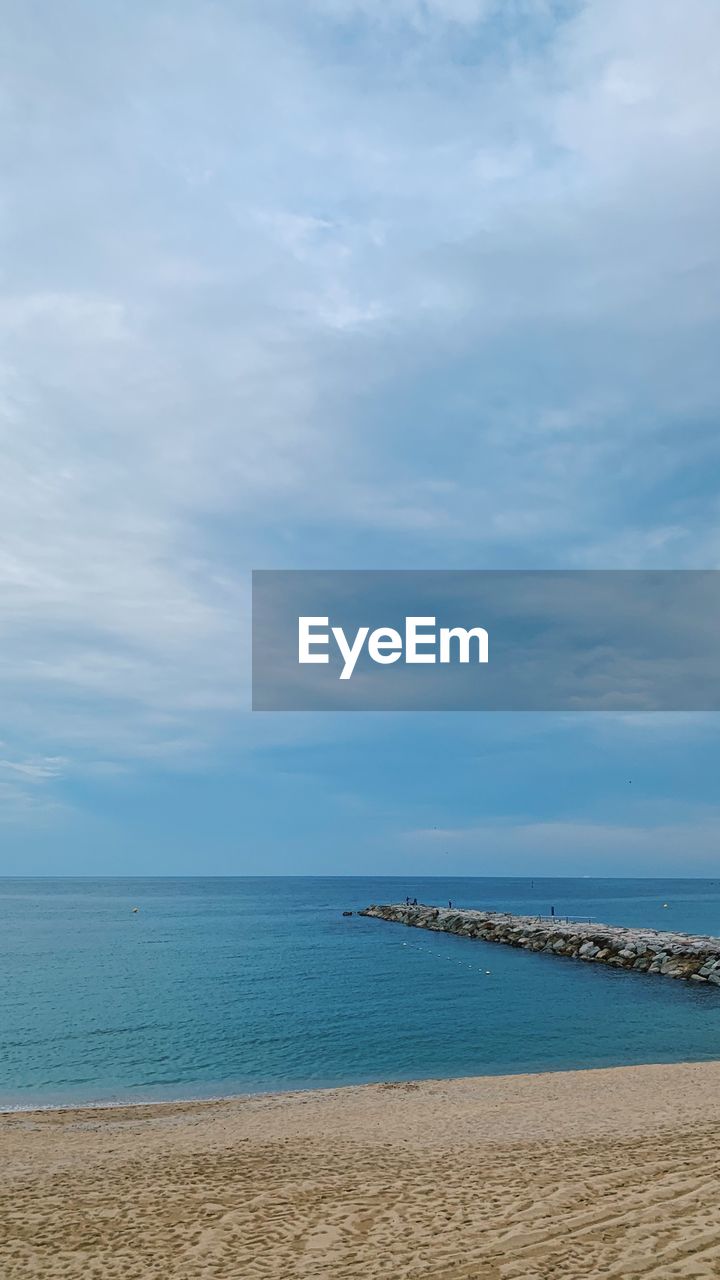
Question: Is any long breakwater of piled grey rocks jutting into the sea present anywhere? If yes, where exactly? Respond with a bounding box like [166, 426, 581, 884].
[357, 904, 720, 987]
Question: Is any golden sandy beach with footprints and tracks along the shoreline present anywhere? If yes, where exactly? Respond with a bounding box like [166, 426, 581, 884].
[0, 1062, 720, 1280]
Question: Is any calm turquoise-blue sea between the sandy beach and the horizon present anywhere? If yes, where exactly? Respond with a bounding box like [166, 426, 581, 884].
[0, 878, 720, 1107]
